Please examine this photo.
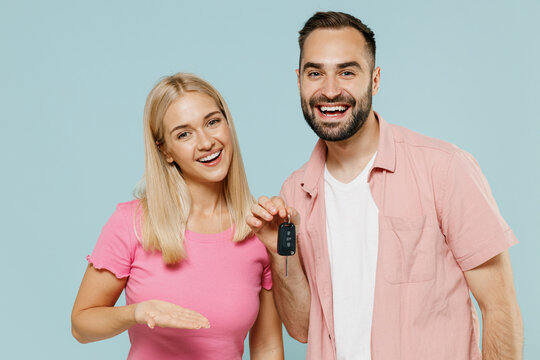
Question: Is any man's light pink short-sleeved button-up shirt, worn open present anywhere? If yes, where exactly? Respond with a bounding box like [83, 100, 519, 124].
[281, 115, 517, 360]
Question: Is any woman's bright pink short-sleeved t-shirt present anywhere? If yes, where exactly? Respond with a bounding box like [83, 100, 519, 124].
[88, 200, 272, 360]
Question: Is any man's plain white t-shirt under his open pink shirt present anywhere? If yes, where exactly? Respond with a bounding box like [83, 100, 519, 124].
[324, 155, 379, 360]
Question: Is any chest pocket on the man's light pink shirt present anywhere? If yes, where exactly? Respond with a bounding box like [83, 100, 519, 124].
[379, 215, 436, 284]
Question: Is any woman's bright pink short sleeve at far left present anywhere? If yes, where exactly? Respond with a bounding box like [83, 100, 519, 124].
[86, 204, 134, 279]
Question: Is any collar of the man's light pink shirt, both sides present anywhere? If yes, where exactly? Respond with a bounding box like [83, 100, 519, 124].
[302, 112, 396, 196]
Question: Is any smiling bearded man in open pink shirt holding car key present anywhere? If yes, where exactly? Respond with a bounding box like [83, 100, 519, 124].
[247, 12, 522, 360]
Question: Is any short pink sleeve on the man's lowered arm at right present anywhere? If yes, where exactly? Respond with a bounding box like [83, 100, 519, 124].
[441, 150, 517, 271]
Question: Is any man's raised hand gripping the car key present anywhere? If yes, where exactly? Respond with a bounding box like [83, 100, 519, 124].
[246, 196, 300, 255]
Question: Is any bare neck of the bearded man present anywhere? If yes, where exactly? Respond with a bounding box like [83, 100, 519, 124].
[325, 110, 379, 183]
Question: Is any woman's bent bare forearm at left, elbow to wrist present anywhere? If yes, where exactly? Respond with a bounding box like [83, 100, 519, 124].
[71, 305, 137, 344]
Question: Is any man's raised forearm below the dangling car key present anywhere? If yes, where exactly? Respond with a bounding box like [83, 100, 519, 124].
[271, 253, 311, 343]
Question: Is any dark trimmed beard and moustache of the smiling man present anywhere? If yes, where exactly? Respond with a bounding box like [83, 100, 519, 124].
[300, 82, 372, 141]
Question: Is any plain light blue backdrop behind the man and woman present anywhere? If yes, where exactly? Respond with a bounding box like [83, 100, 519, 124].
[0, 0, 540, 359]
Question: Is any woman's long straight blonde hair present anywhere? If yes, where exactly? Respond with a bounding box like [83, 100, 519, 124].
[135, 73, 255, 264]
